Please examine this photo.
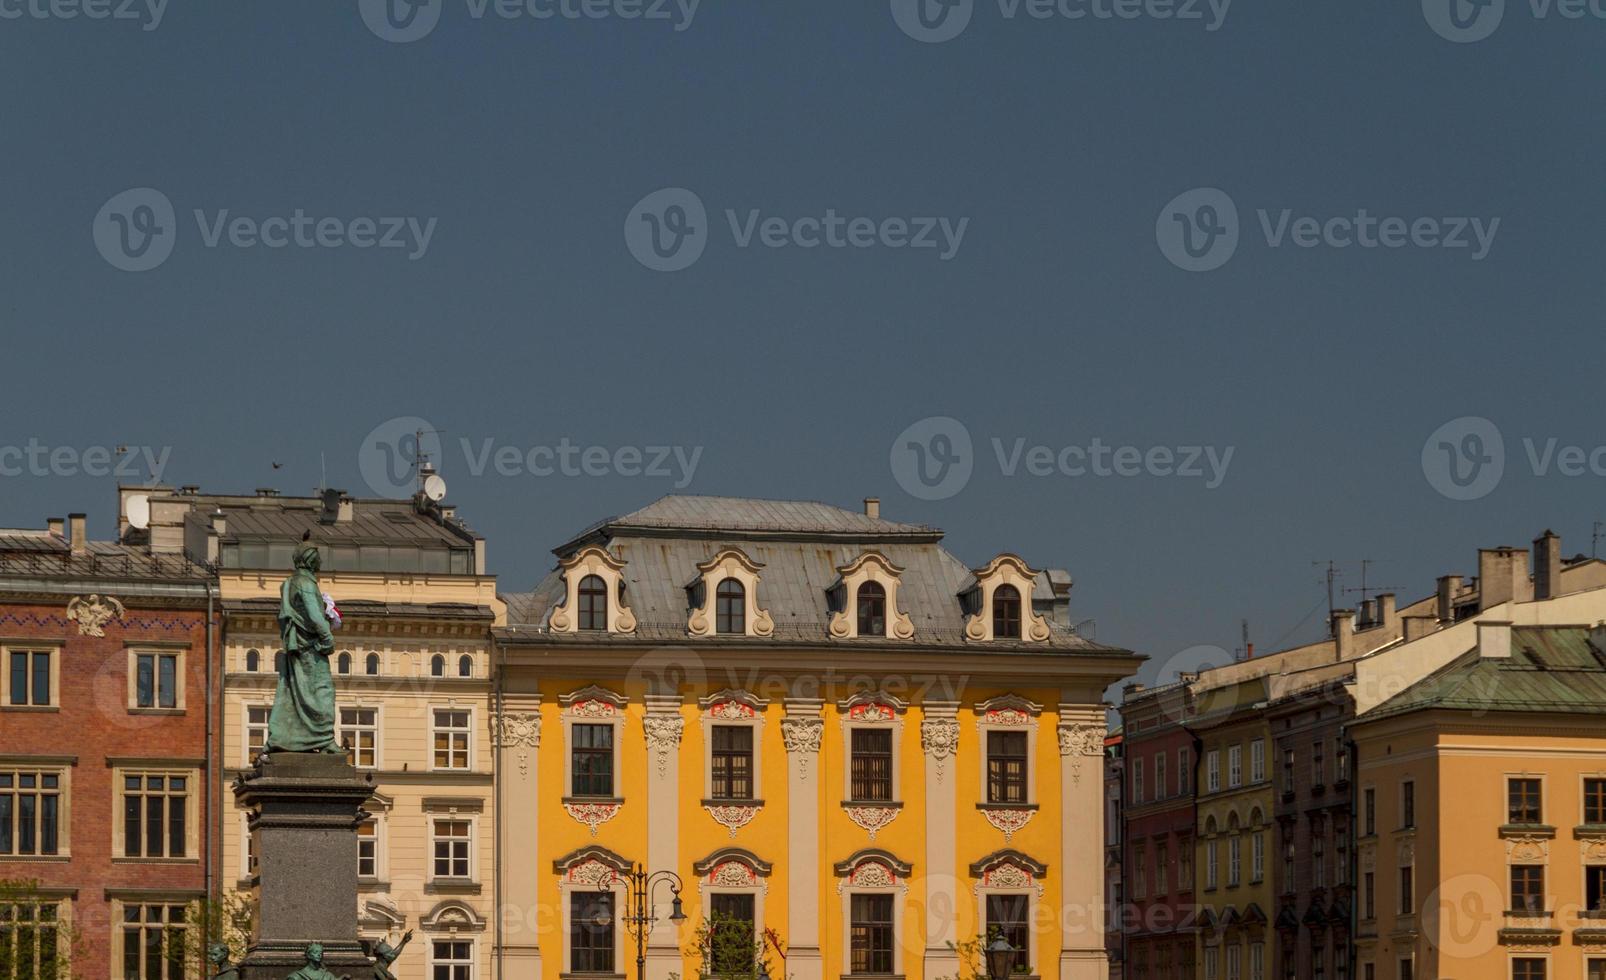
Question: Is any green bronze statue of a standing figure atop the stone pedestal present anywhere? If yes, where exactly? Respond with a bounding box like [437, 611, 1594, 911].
[263, 540, 344, 753]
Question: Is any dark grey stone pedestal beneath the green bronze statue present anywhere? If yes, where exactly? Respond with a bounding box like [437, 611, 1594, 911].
[234, 752, 374, 980]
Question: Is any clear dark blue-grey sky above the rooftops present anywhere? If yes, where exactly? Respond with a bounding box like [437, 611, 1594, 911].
[0, 0, 1606, 684]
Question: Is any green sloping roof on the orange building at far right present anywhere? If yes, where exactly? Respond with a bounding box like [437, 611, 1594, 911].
[1363, 627, 1606, 721]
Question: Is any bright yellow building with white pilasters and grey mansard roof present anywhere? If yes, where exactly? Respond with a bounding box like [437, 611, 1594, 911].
[488, 496, 1139, 980]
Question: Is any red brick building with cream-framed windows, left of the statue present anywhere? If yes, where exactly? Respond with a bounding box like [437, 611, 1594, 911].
[0, 514, 220, 980]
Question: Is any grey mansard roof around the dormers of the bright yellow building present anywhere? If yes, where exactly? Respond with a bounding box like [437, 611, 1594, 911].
[503, 496, 1107, 651]
